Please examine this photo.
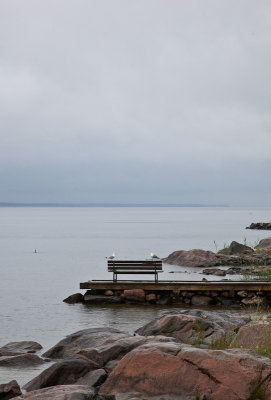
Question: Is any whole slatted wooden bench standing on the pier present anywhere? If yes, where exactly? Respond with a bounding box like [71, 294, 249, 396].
[107, 260, 163, 282]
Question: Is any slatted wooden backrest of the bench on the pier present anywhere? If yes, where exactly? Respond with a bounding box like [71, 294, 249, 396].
[107, 260, 162, 272]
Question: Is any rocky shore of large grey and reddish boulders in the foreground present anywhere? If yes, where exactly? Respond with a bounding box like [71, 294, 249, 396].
[0, 309, 271, 400]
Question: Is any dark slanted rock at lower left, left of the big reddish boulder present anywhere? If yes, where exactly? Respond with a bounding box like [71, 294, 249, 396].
[23, 355, 98, 392]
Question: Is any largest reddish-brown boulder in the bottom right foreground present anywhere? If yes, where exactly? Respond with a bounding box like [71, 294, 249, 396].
[99, 345, 271, 400]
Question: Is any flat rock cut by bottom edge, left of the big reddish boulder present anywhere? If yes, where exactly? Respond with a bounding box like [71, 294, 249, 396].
[15, 385, 94, 400]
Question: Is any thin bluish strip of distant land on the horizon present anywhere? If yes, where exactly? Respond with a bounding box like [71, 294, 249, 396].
[0, 202, 229, 207]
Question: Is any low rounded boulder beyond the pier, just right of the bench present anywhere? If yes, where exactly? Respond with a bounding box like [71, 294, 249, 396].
[163, 249, 222, 268]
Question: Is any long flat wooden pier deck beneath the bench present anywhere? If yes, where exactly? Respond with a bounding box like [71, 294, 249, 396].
[80, 280, 271, 292]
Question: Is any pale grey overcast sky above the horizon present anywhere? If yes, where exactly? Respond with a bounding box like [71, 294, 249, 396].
[0, 0, 271, 206]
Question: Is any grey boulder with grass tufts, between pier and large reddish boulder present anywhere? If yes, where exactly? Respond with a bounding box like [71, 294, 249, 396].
[136, 310, 249, 344]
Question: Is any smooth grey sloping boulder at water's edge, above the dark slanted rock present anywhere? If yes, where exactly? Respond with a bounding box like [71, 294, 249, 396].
[44, 328, 146, 367]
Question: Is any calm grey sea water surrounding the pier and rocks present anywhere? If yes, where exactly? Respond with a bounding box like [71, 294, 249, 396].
[0, 207, 271, 384]
